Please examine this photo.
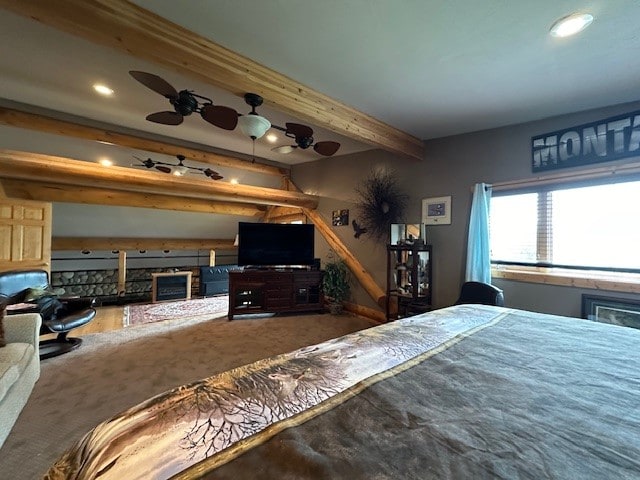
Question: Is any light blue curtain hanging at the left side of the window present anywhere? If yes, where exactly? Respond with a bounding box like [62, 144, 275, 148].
[465, 183, 491, 283]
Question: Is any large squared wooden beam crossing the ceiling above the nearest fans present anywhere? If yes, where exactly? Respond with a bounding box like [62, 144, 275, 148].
[0, 0, 424, 160]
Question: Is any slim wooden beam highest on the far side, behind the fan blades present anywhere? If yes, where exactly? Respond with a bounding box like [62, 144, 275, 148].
[0, 107, 289, 177]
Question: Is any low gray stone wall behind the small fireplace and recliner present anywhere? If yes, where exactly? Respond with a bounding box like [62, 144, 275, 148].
[51, 266, 200, 305]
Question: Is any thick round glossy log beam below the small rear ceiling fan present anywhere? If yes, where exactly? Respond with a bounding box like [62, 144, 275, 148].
[0, 150, 318, 209]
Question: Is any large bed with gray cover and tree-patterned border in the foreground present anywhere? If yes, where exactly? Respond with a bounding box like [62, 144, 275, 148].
[46, 305, 640, 480]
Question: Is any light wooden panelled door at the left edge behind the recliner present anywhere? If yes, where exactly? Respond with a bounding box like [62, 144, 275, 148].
[0, 198, 51, 272]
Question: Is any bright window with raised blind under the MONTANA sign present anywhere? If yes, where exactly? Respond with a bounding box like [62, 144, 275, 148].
[491, 176, 640, 274]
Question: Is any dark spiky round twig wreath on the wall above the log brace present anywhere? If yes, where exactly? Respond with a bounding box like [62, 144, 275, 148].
[356, 170, 409, 243]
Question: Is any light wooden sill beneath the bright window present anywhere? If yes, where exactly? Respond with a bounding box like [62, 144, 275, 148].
[491, 266, 640, 293]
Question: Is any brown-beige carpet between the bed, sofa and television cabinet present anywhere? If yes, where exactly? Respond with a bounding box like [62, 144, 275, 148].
[0, 314, 372, 479]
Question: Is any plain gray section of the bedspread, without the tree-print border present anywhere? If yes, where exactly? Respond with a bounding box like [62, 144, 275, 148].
[192, 311, 640, 480]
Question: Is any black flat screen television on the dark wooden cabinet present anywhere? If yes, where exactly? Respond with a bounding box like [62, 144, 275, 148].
[238, 222, 315, 267]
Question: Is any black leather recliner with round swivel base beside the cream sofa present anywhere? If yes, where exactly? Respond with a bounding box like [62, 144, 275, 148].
[0, 270, 96, 360]
